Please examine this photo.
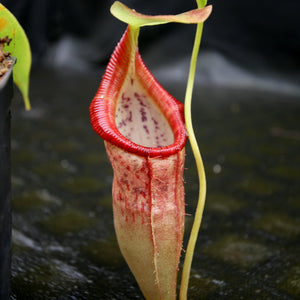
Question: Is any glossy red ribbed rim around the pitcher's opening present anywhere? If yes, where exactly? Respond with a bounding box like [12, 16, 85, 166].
[90, 27, 187, 157]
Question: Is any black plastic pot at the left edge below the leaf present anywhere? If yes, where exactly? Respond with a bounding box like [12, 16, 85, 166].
[0, 59, 13, 300]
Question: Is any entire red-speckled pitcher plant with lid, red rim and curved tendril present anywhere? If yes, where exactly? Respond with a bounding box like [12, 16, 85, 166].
[90, 1, 211, 299]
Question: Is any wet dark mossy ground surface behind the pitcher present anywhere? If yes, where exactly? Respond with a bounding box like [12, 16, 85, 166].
[11, 68, 300, 299]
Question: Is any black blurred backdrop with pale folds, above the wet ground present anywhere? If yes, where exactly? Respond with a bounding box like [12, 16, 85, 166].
[2, 0, 300, 93]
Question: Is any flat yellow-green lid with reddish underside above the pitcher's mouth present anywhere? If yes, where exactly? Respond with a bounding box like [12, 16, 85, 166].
[110, 1, 212, 27]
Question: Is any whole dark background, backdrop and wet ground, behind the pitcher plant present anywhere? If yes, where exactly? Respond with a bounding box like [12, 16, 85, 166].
[0, 0, 300, 300]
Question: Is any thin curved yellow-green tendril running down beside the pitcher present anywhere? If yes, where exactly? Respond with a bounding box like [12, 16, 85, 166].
[179, 1, 206, 300]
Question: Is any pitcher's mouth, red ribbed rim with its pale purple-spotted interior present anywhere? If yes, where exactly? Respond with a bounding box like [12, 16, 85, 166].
[90, 27, 187, 157]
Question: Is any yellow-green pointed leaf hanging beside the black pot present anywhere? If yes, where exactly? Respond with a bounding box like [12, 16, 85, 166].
[0, 4, 31, 110]
